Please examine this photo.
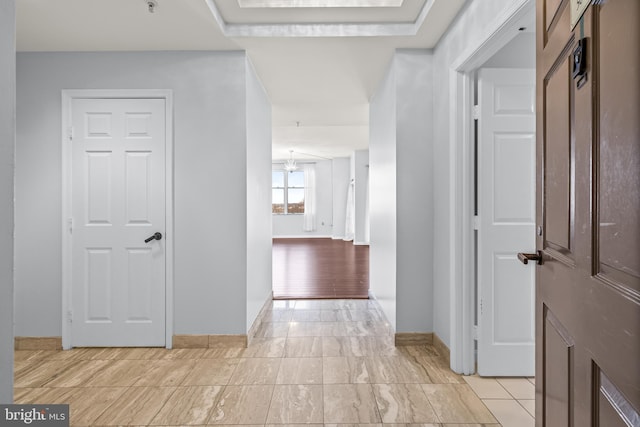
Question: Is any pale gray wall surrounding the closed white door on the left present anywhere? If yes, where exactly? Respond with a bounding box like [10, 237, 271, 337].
[15, 52, 270, 336]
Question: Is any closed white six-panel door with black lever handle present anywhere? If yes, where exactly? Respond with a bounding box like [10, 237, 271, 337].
[70, 99, 166, 347]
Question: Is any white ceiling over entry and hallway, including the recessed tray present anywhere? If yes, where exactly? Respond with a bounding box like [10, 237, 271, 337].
[16, 0, 466, 159]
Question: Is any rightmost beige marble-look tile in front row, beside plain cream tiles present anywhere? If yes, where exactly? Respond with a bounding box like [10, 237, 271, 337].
[422, 384, 496, 423]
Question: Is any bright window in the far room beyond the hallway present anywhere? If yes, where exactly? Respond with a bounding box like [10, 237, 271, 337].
[271, 169, 304, 215]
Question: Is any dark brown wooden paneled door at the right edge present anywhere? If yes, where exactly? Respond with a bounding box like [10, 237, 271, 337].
[536, 0, 640, 427]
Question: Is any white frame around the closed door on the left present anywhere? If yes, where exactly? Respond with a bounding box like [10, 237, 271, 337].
[61, 89, 173, 350]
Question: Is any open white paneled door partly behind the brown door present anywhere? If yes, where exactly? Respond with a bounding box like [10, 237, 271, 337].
[477, 69, 536, 376]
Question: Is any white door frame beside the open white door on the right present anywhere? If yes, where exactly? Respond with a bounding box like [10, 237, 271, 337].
[449, 0, 535, 375]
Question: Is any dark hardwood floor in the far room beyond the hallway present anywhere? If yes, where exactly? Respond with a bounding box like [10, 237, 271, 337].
[273, 239, 369, 299]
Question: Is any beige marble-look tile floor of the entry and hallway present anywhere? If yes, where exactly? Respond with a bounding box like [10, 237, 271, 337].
[15, 300, 534, 427]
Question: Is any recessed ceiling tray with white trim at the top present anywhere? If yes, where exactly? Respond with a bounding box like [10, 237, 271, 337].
[206, 0, 434, 37]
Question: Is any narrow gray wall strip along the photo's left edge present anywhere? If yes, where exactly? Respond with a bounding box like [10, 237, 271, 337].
[0, 0, 16, 404]
